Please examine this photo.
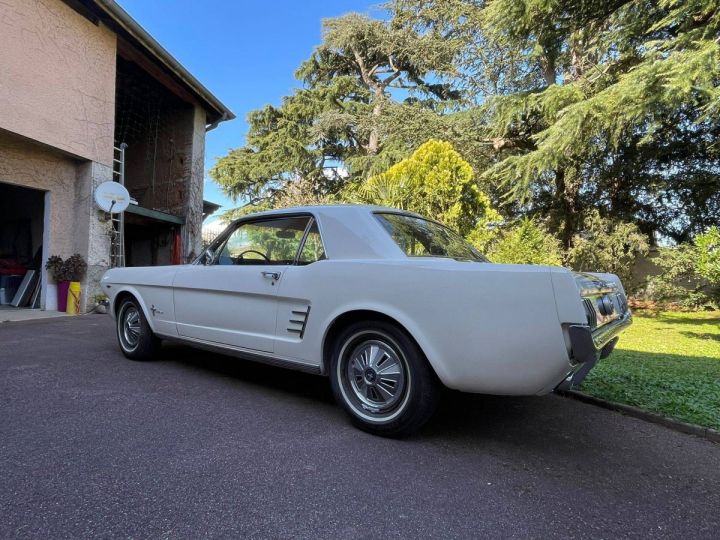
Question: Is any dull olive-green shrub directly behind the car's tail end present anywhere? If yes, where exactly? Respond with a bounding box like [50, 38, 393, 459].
[565, 210, 649, 292]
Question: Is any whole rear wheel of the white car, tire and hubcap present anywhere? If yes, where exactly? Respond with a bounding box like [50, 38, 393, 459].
[330, 321, 440, 437]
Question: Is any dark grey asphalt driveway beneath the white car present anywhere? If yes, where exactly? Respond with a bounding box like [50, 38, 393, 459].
[0, 315, 720, 538]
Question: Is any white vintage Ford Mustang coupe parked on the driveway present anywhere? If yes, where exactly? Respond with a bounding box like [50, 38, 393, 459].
[102, 206, 632, 435]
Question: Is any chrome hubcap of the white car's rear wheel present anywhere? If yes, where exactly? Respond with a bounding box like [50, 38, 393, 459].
[347, 340, 406, 414]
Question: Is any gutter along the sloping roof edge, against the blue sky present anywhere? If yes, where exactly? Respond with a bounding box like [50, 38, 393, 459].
[95, 0, 235, 122]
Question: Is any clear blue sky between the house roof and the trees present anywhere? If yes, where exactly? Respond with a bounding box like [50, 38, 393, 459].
[119, 0, 380, 217]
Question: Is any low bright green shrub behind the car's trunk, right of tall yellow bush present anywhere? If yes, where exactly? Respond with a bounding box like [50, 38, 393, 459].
[487, 218, 562, 266]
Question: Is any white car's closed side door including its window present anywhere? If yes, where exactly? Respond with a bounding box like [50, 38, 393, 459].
[173, 215, 310, 352]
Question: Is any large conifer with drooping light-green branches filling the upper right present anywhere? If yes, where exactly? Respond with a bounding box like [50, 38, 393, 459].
[391, 0, 720, 248]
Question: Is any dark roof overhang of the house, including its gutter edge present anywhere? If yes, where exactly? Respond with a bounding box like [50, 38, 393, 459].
[63, 0, 235, 129]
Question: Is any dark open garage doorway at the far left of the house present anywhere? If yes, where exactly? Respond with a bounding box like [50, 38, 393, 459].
[0, 182, 45, 310]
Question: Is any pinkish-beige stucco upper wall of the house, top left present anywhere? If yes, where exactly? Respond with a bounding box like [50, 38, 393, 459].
[0, 0, 116, 165]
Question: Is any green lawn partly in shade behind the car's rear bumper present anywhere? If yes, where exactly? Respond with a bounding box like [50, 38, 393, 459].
[579, 311, 720, 430]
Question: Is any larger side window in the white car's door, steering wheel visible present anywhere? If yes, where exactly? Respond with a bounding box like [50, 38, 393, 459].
[213, 216, 310, 265]
